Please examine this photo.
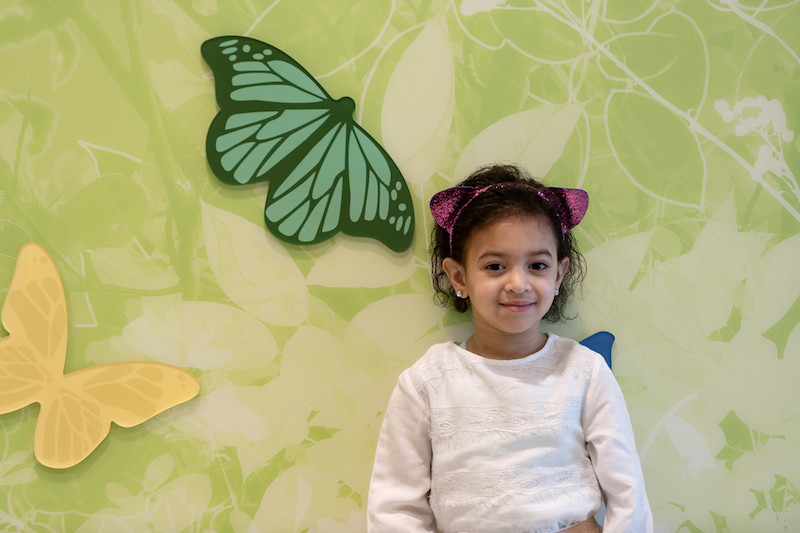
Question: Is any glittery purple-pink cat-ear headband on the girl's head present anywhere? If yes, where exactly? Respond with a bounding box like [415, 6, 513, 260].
[430, 182, 589, 253]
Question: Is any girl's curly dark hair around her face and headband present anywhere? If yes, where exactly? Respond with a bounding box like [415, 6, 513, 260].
[429, 164, 586, 322]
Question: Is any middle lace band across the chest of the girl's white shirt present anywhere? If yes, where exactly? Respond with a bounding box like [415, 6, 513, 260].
[430, 396, 583, 445]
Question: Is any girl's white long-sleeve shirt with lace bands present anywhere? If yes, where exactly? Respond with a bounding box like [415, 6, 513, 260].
[367, 334, 653, 533]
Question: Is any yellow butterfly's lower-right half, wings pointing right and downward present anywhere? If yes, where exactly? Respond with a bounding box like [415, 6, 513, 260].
[34, 361, 200, 468]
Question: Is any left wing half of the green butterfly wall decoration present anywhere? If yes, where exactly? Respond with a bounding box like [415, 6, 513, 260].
[201, 36, 340, 184]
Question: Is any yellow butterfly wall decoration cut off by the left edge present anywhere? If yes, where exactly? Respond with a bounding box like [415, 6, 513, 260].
[0, 242, 200, 468]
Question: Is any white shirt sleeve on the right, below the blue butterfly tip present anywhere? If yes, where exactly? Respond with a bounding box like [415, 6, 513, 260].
[583, 358, 653, 533]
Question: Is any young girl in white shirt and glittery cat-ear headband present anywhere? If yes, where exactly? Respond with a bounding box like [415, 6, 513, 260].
[368, 166, 653, 533]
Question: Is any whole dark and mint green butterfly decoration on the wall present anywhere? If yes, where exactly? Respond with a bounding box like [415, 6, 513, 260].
[201, 36, 414, 252]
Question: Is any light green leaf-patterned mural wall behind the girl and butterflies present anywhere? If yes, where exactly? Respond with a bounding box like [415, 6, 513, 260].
[0, 0, 800, 533]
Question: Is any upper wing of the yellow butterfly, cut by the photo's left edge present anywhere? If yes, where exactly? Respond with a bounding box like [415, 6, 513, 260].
[0, 242, 67, 413]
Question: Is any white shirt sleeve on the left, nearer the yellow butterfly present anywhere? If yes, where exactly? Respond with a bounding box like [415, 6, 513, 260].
[367, 372, 437, 533]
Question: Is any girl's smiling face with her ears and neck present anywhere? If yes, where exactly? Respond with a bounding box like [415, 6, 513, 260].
[443, 217, 569, 358]
